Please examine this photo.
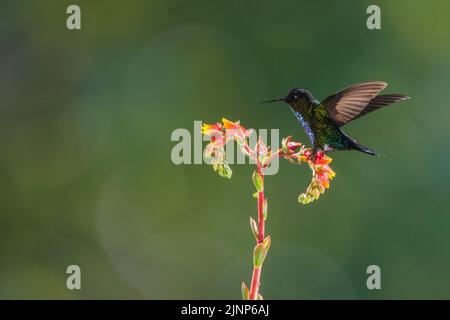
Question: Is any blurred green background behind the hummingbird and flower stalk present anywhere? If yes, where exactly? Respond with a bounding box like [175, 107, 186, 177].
[0, 0, 450, 299]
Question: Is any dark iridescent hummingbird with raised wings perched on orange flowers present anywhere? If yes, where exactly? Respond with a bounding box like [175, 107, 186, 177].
[261, 81, 410, 156]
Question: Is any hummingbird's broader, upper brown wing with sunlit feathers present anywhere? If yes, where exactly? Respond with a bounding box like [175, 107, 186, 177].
[321, 81, 387, 126]
